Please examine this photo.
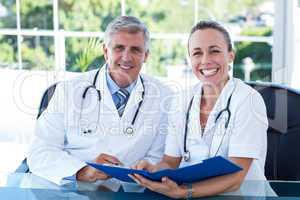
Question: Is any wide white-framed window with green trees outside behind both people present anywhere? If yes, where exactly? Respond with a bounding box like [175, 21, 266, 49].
[0, 0, 274, 81]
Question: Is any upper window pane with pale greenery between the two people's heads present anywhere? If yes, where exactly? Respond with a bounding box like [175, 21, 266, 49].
[126, 0, 194, 33]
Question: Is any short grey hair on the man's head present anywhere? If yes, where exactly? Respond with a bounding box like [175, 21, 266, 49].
[104, 16, 150, 51]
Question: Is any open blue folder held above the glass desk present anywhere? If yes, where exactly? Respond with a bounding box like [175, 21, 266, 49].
[87, 156, 242, 184]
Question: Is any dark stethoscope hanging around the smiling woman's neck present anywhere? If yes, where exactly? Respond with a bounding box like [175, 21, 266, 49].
[183, 82, 236, 162]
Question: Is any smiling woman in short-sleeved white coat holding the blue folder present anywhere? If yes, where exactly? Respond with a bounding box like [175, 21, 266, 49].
[131, 21, 268, 198]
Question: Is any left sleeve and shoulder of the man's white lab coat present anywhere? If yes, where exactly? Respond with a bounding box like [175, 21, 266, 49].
[27, 71, 96, 184]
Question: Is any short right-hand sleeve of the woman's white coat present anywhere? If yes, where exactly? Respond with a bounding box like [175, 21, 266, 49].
[228, 79, 268, 161]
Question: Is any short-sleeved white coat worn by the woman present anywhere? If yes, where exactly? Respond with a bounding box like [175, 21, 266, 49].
[165, 78, 268, 180]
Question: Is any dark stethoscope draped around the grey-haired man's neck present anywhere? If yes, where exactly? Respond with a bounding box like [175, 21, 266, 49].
[79, 69, 145, 135]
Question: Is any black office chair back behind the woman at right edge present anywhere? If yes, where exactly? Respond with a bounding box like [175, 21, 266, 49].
[247, 82, 300, 181]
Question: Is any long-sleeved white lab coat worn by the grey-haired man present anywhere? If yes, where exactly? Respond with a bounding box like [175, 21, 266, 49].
[28, 67, 172, 184]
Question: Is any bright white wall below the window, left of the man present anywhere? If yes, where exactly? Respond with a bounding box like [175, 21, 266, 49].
[0, 69, 77, 172]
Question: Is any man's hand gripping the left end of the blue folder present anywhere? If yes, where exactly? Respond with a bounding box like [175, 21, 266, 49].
[76, 153, 122, 182]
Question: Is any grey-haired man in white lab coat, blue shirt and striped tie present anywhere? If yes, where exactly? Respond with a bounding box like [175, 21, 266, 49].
[28, 16, 171, 184]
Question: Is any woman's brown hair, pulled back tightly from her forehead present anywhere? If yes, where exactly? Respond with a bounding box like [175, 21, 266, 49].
[188, 20, 233, 51]
